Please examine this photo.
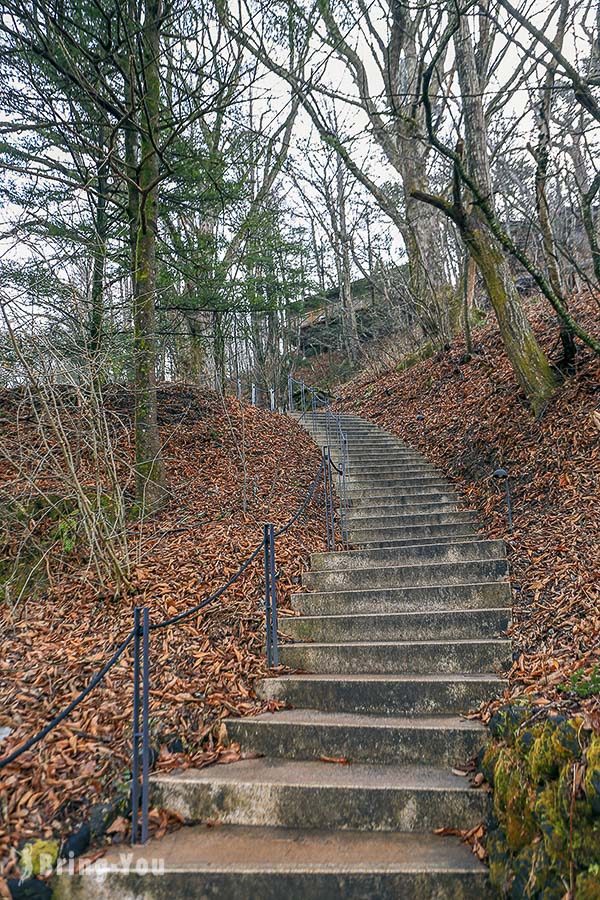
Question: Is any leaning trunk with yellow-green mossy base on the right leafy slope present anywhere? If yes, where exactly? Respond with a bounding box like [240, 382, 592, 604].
[454, 15, 555, 415]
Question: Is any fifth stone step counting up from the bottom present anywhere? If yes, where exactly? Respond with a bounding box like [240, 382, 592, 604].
[279, 638, 510, 675]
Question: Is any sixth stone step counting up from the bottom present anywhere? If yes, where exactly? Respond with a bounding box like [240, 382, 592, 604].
[279, 607, 511, 643]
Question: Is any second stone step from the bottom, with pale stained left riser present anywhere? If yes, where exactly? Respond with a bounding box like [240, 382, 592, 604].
[151, 758, 488, 831]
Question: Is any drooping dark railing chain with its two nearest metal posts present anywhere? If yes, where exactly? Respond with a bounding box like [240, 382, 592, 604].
[0, 436, 329, 844]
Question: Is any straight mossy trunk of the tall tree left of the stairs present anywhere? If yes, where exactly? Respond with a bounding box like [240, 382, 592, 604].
[133, 0, 166, 513]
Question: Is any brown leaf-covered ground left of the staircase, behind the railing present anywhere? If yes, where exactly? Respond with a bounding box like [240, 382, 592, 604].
[0, 386, 325, 882]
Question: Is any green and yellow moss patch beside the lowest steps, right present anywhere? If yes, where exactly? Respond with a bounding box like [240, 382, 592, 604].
[481, 705, 600, 900]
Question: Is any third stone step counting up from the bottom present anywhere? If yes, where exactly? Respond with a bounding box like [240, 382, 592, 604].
[225, 709, 487, 767]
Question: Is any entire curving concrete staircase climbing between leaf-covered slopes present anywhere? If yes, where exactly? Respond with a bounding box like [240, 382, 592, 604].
[54, 413, 511, 900]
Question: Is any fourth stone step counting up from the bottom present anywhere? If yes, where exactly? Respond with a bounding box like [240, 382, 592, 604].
[257, 673, 506, 716]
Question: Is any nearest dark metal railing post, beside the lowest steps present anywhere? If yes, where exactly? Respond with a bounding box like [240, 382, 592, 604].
[131, 606, 150, 844]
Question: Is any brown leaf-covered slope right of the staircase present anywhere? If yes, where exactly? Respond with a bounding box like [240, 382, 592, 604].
[339, 297, 600, 730]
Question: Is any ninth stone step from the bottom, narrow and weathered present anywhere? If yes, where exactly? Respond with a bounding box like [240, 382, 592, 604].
[310, 541, 506, 572]
